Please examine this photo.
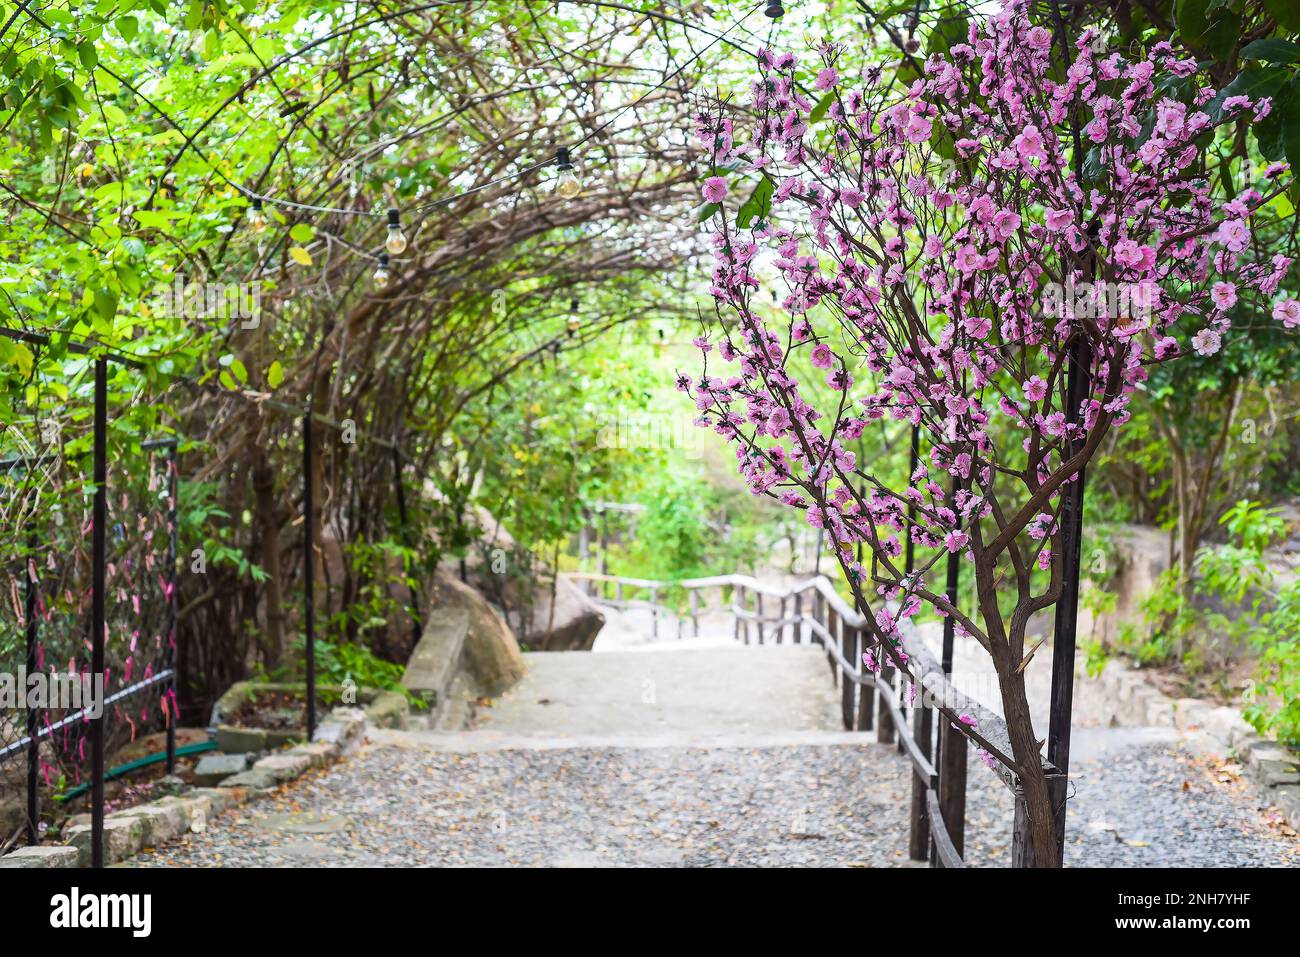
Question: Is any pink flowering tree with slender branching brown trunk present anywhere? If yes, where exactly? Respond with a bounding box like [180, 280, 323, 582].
[679, 0, 1300, 866]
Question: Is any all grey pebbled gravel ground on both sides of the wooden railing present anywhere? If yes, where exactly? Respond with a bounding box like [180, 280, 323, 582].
[134, 732, 1300, 867]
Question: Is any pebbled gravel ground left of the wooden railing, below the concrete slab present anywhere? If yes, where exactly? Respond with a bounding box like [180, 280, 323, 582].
[134, 732, 925, 867]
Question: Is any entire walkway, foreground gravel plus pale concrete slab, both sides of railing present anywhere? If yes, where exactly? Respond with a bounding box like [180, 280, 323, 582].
[133, 613, 1300, 867]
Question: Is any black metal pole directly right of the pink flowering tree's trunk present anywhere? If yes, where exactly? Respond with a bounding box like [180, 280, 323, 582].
[1048, 334, 1092, 859]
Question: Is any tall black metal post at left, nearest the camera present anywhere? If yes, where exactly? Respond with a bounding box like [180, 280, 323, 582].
[90, 359, 108, 867]
